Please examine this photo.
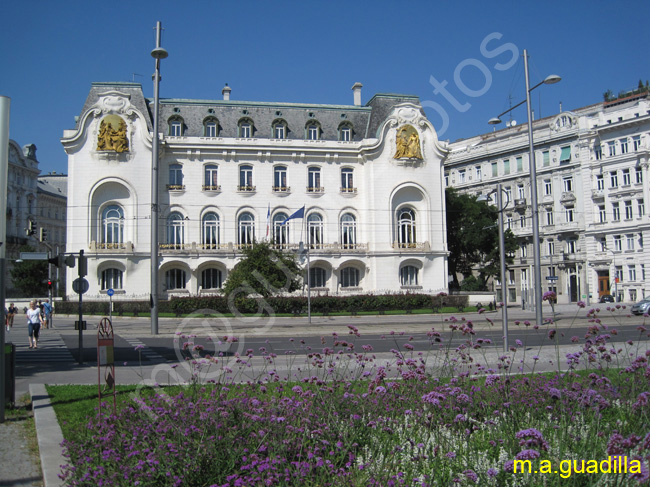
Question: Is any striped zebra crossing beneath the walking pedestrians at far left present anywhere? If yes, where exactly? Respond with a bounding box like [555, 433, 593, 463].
[5, 324, 75, 365]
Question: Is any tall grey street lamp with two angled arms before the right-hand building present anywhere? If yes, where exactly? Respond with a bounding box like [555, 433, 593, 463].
[488, 49, 562, 325]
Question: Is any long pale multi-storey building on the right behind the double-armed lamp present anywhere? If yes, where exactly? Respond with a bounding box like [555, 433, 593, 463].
[445, 91, 650, 304]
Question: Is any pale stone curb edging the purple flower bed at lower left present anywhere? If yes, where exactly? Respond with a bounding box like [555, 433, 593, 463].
[29, 384, 67, 487]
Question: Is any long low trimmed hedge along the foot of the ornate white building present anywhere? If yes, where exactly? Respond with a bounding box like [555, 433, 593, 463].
[56, 293, 468, 316]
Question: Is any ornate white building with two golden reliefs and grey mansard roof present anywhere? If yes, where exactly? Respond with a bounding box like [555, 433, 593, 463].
[62, 83, 448, 299]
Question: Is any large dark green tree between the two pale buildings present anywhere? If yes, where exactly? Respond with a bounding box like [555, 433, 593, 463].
[445, 188, 517, 289]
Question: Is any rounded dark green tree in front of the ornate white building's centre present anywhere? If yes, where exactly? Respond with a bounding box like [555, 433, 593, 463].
[223, 242, 301, 297]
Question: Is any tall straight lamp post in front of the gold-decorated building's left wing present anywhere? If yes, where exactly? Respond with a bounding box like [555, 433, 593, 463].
[149, 22, 168, 335]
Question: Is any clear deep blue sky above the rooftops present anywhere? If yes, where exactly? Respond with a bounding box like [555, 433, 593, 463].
[0, 0, 650, 173]
